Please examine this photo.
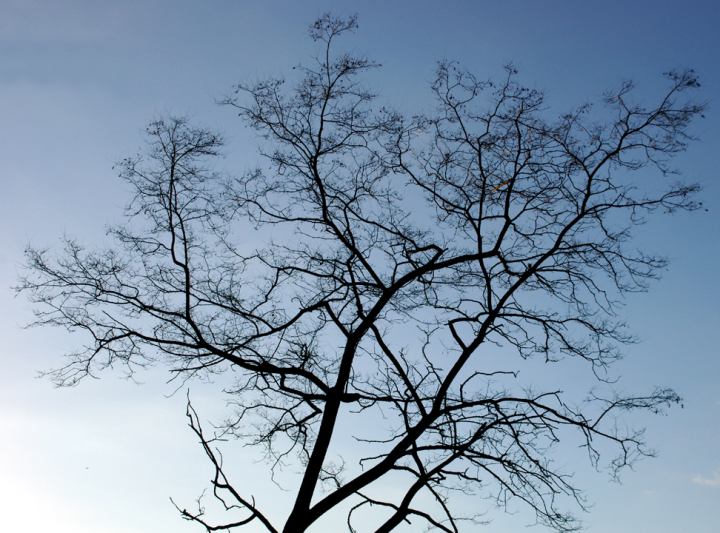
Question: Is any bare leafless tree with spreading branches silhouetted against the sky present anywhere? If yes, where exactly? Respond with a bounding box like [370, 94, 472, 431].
[18, 15, 704, 533]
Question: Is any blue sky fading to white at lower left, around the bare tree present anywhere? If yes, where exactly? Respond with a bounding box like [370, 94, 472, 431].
[0, 0, 720, 533]
